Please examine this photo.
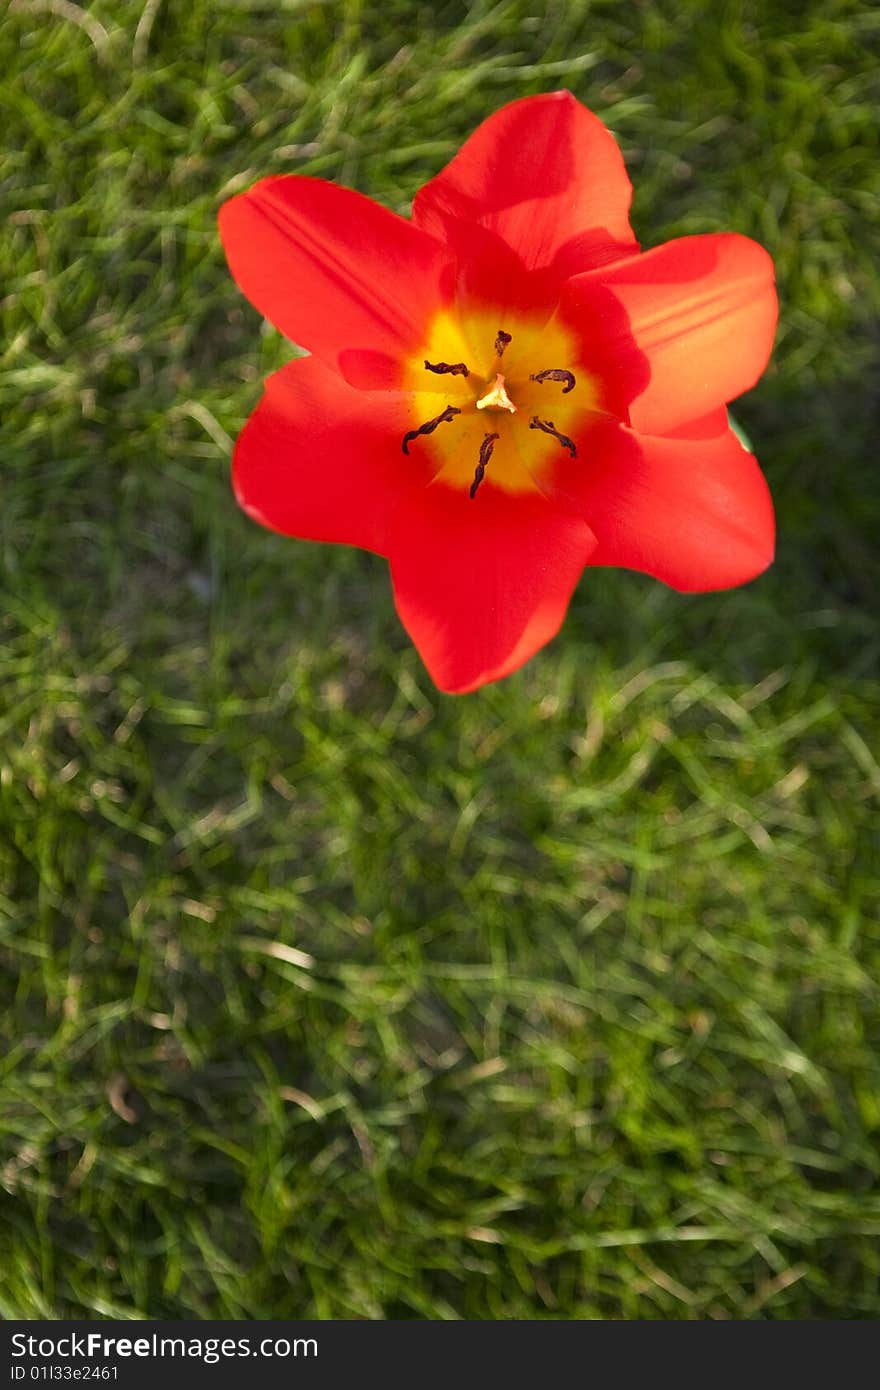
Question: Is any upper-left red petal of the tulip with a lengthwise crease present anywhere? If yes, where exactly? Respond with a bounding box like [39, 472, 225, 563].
[220, 175, 455, 385]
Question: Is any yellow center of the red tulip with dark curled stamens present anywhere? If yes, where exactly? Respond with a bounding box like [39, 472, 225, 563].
[402, 310, 599, 499]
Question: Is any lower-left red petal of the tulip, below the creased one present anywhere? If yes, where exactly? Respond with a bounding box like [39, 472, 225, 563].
[232, 357, 430, 555]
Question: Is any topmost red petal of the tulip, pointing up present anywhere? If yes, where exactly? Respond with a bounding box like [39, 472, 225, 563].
[413, 92, 638, 290]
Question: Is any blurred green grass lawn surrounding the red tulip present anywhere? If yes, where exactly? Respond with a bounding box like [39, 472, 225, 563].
[0, 0, 880, 1319]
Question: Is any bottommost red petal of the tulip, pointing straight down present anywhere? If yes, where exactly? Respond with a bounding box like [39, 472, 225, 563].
[391, 480, 595, 694]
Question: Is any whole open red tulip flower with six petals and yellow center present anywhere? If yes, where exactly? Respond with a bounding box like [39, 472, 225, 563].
[220, 92, 777, 692]
